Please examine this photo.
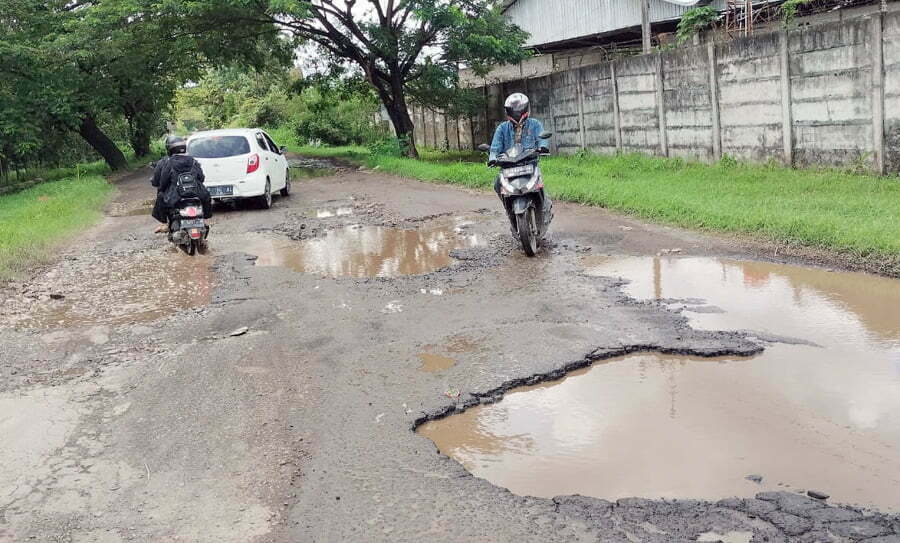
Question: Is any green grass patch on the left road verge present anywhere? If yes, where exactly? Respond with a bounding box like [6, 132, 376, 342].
[0, 175, 114, 280]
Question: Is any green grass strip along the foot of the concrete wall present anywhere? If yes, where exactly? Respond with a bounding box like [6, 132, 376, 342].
[292, 143, 900, 275]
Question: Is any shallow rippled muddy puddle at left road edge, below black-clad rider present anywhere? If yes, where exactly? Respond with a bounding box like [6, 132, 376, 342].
[0, 254, 214, 328]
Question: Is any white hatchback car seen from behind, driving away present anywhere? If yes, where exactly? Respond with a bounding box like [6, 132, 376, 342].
[187, 128, 291, 209]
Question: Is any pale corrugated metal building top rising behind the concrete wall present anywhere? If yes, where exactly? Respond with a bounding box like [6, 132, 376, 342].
[505, 0, 725, 46]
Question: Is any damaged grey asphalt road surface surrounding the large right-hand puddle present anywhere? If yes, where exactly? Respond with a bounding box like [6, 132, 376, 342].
[0, 159, 900, 542]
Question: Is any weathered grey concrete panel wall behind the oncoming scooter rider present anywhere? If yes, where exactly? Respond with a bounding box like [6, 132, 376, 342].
[416, 12, 900, 172]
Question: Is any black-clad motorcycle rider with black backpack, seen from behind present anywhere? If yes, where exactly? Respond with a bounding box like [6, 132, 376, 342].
[151, 136, 212, 233]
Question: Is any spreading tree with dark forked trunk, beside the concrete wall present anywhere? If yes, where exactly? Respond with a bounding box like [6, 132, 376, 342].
[232, 0, 527, 157]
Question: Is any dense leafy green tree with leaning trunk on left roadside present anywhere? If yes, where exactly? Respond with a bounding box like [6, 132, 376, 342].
[0, 0, 291, 169]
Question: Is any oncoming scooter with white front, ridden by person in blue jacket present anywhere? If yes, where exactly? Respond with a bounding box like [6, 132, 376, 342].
[478, 132, 553, 256]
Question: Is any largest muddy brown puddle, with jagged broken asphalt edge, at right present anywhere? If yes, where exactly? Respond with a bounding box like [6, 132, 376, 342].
[419, 257, 900, 512]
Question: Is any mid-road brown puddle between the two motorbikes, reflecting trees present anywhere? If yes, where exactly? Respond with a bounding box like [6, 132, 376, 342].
[239, 218, 483, 277]
